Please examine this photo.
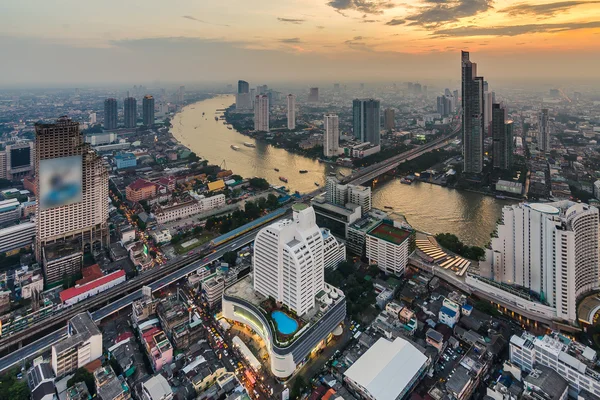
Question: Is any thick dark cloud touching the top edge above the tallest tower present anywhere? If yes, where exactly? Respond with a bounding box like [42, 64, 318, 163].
[406, 0, 493, 28]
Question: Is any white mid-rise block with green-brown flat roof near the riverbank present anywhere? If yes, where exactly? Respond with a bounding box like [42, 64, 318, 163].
[366, 221, 412, 276]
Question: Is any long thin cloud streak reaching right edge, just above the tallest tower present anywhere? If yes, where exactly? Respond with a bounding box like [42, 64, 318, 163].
[434, 21, 600, 37]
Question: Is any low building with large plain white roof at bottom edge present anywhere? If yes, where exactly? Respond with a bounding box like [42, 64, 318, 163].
[344, 338, 430, 400]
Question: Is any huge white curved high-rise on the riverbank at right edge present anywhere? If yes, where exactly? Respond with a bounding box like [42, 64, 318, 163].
[480, 201, 600, 321]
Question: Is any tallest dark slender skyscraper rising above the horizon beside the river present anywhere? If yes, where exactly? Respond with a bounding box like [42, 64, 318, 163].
[461, 51, 484, 174]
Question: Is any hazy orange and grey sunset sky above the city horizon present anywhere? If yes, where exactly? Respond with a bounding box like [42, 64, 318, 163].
[0, 0, 600, 84]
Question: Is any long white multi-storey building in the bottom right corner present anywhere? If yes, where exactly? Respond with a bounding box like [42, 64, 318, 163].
[510, 332, 600, 398]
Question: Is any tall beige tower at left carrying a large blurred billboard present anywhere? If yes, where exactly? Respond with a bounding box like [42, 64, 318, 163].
[35, 117, 109, 283]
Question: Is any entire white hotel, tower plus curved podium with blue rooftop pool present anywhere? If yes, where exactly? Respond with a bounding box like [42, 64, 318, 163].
[222, 203, 346, 378]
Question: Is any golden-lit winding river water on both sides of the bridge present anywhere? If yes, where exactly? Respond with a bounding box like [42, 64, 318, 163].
[171, 95, 509, 246]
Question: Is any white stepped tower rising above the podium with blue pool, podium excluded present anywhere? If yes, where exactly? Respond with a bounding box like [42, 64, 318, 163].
[253, 203, 325, 316]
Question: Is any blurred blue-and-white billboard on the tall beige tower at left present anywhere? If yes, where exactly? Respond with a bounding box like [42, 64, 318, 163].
[39, 156, 83, 210]
